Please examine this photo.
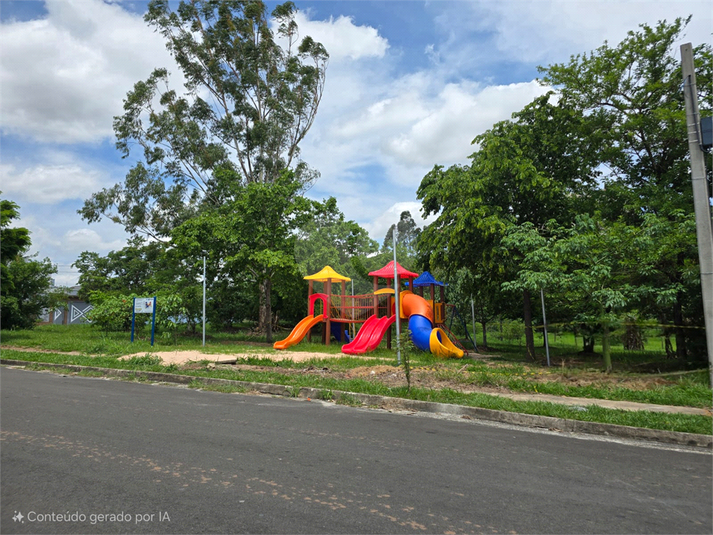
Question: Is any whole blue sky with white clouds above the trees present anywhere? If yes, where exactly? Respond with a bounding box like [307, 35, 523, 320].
[0, 0, 713, 285]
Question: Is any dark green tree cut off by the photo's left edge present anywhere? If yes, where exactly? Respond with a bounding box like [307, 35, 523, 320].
[0, 199, 57, 329]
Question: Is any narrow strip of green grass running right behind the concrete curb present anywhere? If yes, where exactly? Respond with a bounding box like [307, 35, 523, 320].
[2, 350, 712, 435]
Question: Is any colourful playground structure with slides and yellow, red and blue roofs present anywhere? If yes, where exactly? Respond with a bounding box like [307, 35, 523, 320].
[273, 261, 465, 358]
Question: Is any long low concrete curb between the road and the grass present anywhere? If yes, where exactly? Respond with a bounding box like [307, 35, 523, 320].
[0, 359, 713, 450]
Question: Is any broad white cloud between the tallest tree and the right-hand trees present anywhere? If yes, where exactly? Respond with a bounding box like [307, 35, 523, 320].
[303, 72, 547, 202]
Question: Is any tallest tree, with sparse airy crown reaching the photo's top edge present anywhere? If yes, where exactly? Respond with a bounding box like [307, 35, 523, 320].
[80, 0, 328, 340]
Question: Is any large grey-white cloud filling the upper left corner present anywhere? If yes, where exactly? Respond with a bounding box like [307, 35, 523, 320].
[0, 0, 175, 143]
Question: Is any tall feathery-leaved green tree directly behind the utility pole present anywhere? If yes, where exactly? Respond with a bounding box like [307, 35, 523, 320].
[540, 17, 713, 358]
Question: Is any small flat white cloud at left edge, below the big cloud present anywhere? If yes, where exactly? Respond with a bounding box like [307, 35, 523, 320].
[0, 163, 106, 204]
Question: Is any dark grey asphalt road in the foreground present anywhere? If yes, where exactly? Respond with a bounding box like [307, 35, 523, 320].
[0, 368, 713, 534]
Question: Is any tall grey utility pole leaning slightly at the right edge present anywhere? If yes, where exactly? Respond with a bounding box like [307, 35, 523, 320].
[681, 43, 713, 387]
